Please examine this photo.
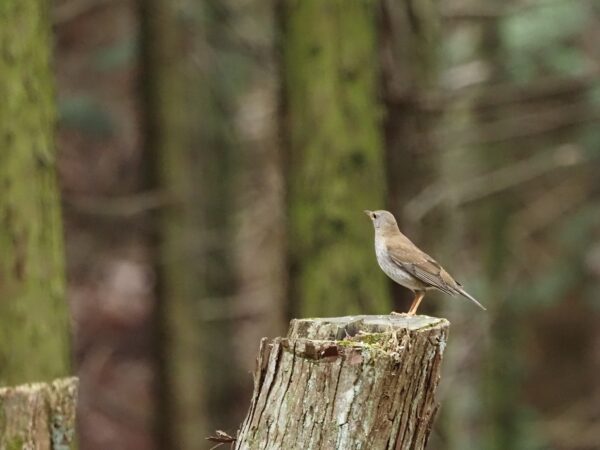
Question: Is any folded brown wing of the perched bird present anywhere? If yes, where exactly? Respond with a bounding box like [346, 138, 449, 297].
[388, 245, 460, 295]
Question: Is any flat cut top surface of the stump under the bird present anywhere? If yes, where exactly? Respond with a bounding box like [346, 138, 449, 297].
[287, 315, 449, 341]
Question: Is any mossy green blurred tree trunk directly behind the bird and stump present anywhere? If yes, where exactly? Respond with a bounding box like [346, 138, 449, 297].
[281, 0, 391, 316]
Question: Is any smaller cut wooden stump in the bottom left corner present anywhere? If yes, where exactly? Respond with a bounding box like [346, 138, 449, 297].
[0, 378, 77, 450]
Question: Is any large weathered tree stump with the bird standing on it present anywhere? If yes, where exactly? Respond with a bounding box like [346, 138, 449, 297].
[235, 315, 449, 450]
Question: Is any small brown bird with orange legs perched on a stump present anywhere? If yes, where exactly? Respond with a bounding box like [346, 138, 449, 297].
[364, 210, 485, 316]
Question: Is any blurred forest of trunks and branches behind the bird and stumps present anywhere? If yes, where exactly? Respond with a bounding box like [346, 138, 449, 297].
[0, 0, 600, 450]
